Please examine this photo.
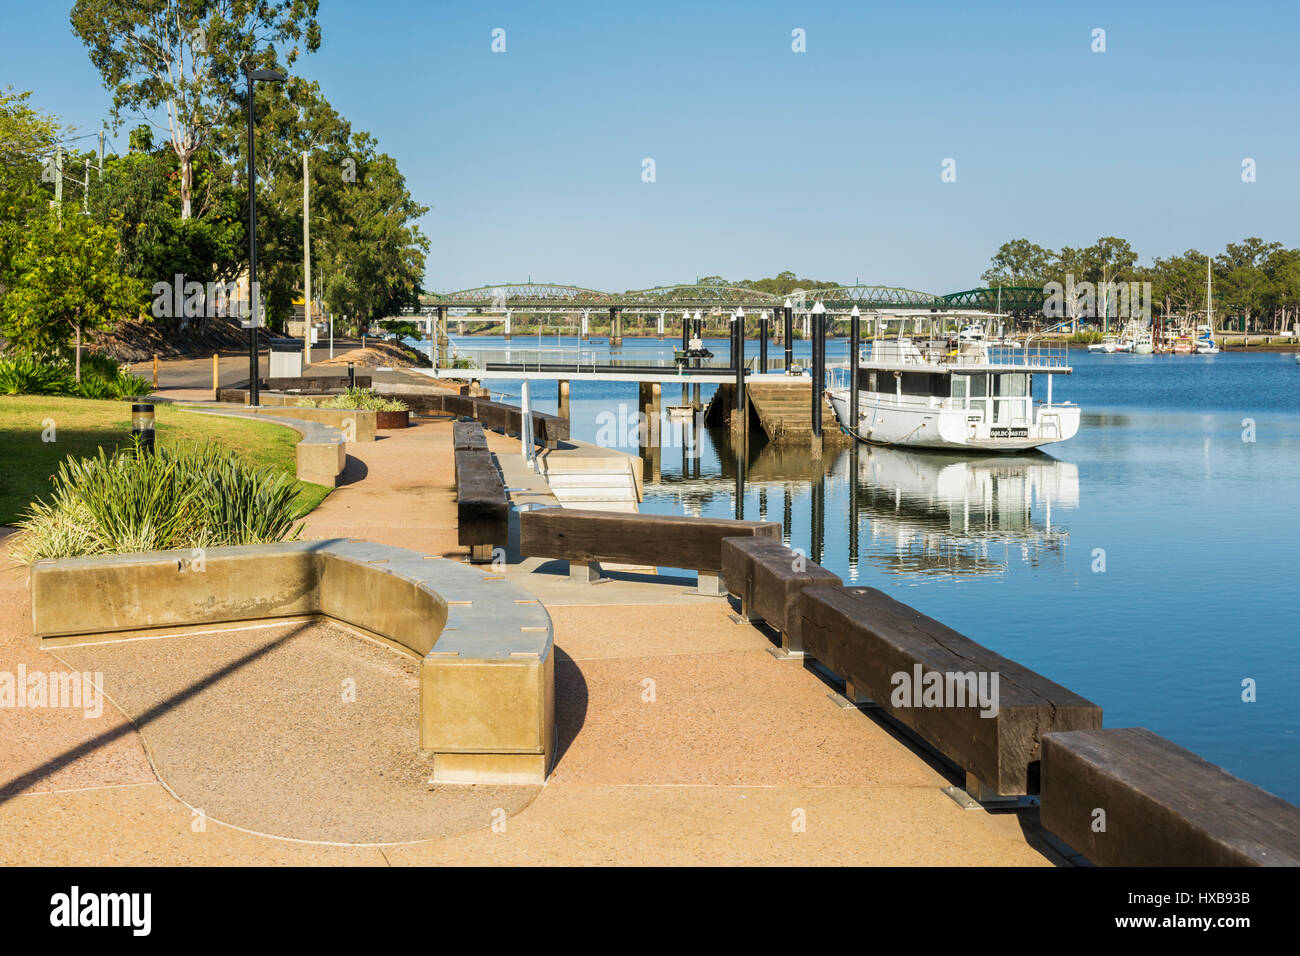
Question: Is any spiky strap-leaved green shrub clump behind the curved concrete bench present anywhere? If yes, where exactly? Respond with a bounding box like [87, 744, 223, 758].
[14, 444, 302, 563]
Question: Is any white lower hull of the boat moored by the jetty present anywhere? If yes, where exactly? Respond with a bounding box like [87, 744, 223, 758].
[826, 389, 1080, 453]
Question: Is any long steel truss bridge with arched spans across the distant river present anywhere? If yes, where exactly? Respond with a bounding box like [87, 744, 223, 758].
[411, 282, 1047, 321]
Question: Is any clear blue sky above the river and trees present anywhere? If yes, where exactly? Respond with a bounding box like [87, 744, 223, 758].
[0, 0, 1300, 293]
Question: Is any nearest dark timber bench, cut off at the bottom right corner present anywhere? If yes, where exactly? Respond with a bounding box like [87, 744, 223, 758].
[1041, 727, 1300, 866]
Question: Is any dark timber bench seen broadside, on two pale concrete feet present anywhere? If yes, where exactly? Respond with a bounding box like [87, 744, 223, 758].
[519, 507, 781, 596]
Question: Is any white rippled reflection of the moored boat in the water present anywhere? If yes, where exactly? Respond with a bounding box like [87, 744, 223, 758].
[836, 446, 1079, 576]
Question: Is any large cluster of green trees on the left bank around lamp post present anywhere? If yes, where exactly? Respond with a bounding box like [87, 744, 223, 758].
[0, 0, 429, 352]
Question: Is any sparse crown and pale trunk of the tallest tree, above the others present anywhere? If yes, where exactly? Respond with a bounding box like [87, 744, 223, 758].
[72, 0, 320, 220]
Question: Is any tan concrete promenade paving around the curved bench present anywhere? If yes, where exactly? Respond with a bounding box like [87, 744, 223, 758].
[0, 395, 1061, 865]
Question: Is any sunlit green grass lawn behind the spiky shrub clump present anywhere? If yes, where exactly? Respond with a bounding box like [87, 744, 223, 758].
[0, 395, 330, 524]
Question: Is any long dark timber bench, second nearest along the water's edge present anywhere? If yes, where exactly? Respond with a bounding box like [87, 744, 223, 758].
[797, 587, 1101, 800]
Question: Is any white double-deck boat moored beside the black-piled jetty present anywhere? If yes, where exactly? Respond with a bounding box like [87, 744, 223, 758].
[826, 312, 1080, 453]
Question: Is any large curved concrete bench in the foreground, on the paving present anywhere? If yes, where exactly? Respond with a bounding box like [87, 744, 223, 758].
[31, 538, 555, 783]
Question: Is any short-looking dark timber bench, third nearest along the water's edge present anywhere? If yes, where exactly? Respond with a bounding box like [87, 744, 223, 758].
[722, 537, 844, 656]
